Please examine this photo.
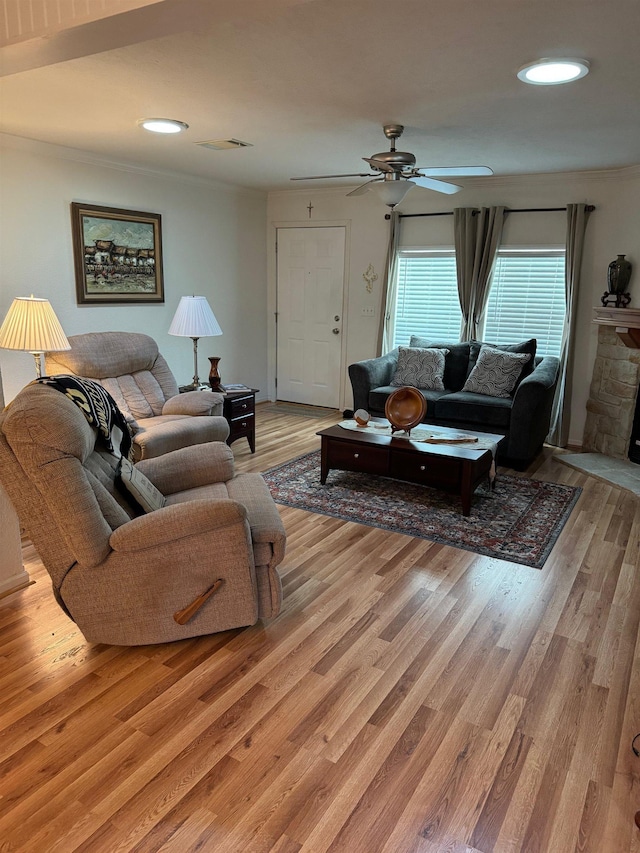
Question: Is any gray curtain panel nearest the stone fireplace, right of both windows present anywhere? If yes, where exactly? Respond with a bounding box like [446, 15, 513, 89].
[547, 204, 590, 447]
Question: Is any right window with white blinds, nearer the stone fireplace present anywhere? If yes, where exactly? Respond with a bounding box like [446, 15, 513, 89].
[482, 248, 566, 356]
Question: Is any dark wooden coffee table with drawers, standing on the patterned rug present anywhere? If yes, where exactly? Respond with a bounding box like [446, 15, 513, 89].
[316, 418, 504, 515]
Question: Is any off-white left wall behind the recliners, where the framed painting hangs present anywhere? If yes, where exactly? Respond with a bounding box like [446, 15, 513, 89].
[0, 135, 267, 401]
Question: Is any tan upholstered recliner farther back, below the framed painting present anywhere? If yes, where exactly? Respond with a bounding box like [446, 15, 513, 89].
[45, 332, 229, 460]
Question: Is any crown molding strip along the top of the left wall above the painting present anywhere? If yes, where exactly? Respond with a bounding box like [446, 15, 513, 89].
[0, 133, 267, 198]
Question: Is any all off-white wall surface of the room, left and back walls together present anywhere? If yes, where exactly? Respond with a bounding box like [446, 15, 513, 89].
[0, 130, 640, 444]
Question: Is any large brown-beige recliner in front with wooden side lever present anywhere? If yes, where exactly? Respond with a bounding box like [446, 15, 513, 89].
[0, 384, 285, 645]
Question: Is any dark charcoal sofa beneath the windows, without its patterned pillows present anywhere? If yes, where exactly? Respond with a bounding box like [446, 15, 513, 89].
[349, 335, 559, 469]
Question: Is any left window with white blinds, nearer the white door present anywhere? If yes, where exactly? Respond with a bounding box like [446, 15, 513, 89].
[393, 249, 462, 347]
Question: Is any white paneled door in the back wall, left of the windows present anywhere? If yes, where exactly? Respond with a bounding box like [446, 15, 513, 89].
[276, 226, 345, 409]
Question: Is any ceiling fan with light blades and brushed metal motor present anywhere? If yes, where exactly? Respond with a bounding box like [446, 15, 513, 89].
[291, 124, 493, 208]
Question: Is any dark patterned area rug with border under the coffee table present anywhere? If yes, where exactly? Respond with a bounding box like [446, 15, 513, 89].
[263, 451, 582, 569]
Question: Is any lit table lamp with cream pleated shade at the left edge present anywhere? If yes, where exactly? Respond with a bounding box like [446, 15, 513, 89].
[0, 294, 71, 377]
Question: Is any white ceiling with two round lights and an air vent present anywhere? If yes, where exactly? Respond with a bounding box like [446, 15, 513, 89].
[0, 0, 640, 189]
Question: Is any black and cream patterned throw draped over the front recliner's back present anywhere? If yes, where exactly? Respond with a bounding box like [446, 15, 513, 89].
[33, 374, 133, 461]
